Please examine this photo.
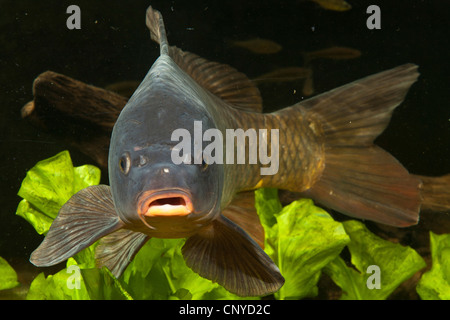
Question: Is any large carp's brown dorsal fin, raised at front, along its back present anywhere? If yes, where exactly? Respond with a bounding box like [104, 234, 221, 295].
[146, 7, 262, 112]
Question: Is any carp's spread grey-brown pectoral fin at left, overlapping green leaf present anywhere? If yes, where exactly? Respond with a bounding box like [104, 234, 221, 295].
[30, 185, 123, 267]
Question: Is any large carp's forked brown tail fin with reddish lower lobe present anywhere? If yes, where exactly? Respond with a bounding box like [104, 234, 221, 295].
[300, 64, 421, 226]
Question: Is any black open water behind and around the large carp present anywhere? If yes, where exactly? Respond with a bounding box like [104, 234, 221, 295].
[0, 0, 450, 296]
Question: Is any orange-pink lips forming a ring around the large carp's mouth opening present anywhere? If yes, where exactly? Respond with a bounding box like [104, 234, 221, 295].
[137, 189, 194, 218]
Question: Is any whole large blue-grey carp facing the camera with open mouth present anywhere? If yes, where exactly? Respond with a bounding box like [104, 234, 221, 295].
[31, 7, 432, 296]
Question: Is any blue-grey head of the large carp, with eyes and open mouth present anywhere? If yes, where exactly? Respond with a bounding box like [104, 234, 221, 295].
[108, 56, 223, 238]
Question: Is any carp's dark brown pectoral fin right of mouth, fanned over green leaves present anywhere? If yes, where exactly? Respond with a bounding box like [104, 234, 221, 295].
[182, 216, 284, 296]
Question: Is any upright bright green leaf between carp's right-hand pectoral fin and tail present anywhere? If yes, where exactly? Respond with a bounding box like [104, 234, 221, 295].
[255, 189, 349, 299]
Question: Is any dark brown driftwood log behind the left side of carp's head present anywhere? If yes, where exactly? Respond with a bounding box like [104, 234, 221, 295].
[22, 71, 128, 168]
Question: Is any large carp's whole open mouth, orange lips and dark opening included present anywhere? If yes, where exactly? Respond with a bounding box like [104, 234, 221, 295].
[138, 190, 194, 217]
